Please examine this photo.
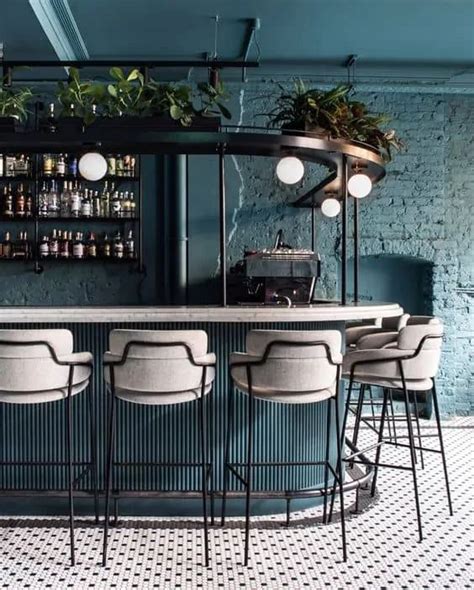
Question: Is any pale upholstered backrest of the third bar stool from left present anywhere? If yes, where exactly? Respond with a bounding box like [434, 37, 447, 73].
[246, 330, 341, 393]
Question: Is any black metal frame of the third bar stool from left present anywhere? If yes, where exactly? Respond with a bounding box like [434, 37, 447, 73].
[221, 339, 347, 566]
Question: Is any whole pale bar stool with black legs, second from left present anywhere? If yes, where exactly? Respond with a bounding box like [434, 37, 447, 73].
[103, 330, 216, 566]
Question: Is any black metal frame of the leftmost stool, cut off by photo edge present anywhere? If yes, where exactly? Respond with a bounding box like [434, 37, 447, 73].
[0, 340, 99, 565]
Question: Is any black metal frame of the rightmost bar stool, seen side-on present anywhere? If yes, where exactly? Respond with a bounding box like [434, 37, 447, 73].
[343, 335, 453, 542]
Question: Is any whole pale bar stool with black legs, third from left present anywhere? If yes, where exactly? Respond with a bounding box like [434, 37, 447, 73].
[222, 330, 347, 565]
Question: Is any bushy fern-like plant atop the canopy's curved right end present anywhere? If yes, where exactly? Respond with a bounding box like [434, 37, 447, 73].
[268, 80, 404, 161]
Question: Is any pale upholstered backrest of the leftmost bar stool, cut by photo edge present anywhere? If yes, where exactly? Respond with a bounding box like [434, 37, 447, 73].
[0, 330, 73, 392]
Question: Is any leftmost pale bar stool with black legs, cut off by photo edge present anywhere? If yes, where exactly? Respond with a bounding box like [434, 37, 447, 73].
[0, 330, 99, 565]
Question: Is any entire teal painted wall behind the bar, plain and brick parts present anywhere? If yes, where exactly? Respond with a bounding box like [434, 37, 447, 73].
[0, 82, 474, 414]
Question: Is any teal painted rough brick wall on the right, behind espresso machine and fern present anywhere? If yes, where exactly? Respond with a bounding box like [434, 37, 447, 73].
[225, 83, 474, 414]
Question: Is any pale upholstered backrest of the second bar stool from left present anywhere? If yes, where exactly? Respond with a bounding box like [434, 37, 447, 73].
[105, 330, 214, 393]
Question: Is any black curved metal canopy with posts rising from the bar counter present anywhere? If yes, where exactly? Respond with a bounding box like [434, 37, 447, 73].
[0, 128, 385, 306]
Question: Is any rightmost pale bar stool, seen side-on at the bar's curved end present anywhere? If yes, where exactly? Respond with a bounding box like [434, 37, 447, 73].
[343, 318, 453, 541]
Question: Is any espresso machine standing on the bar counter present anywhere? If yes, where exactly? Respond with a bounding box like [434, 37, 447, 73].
[228, 229, 321, 306]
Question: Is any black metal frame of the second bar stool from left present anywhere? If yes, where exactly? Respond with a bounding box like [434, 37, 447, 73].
[102, 340, 216, 567]
